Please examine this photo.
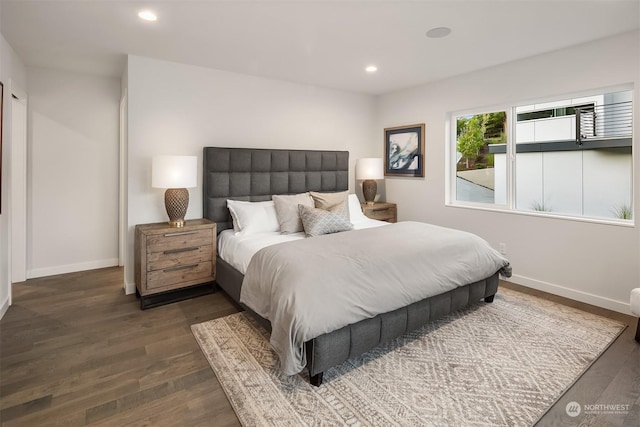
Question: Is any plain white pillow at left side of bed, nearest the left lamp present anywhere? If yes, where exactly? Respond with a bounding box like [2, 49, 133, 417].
[227, 200, 280, 234]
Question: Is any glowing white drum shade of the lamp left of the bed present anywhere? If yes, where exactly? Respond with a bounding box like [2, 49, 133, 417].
[151, 156, 198, 188]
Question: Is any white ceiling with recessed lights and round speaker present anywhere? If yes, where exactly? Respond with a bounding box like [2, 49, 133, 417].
[0, 0, 640, 94]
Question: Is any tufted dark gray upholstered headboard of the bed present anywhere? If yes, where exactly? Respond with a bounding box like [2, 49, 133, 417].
[202, 147, 349, 233]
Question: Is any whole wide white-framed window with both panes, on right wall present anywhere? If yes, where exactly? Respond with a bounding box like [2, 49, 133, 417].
[451, 86, 633, 221]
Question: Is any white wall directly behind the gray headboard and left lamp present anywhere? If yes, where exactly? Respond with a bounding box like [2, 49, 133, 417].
[125, 56, 379, 292]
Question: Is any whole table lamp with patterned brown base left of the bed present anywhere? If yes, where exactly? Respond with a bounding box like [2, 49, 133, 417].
[151, 156, 198, 227]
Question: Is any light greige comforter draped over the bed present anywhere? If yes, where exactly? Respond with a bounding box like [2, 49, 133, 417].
[240, 222, 510, 375]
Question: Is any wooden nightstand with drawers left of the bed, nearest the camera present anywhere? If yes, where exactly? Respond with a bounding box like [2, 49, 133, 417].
[135, 219, 216, 310]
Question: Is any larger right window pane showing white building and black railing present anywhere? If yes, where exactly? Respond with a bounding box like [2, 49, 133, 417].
[515, 91, 633, 219]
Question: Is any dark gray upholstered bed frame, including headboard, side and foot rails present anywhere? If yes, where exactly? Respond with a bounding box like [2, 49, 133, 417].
[203, 147, 498, 386]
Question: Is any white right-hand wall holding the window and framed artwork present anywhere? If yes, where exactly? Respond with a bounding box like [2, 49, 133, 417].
[377, 32, 640, 312]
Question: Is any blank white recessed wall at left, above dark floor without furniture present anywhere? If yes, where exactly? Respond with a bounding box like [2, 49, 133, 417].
[27, 67, 120, 277]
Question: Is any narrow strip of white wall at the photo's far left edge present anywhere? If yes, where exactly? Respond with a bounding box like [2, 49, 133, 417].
[0, 29, 27, 318]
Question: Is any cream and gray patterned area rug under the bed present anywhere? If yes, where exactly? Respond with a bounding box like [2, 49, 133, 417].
[192, 289, 624, 426]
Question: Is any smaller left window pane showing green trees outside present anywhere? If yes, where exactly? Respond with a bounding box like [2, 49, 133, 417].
[455, 111, 507, 204]
